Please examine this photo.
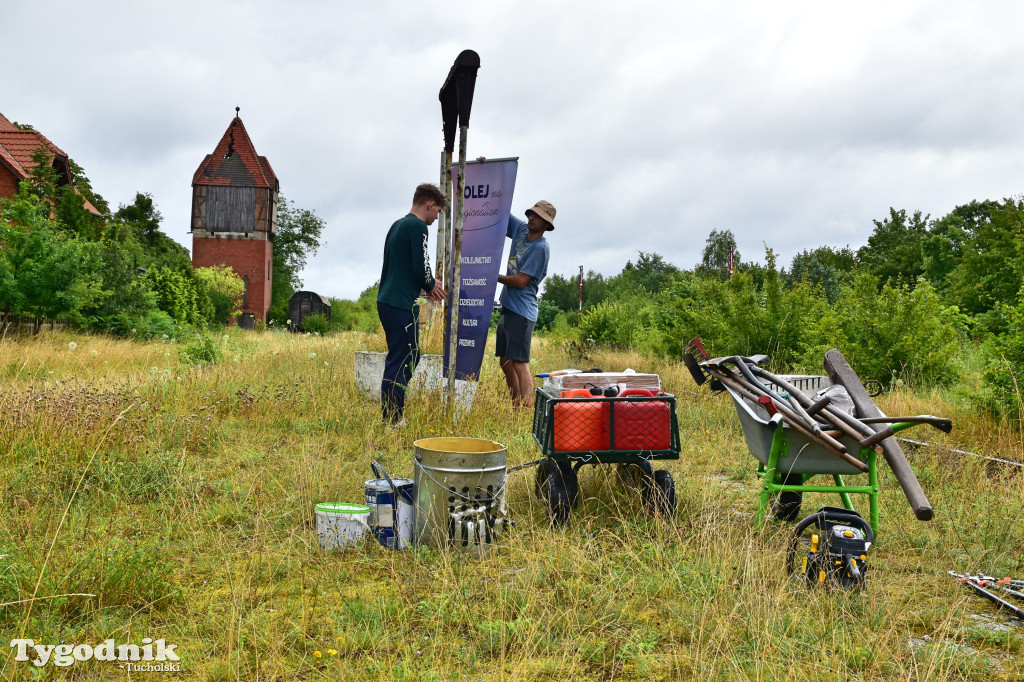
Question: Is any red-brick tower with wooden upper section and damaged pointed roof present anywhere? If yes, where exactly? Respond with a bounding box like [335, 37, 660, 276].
[191, 108, 281, 329]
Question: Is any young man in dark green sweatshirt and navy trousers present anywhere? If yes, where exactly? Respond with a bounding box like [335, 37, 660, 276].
[377, 183, 447, 425]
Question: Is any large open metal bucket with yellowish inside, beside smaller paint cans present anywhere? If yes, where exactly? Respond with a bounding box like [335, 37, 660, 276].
[413, 438, 509, 558]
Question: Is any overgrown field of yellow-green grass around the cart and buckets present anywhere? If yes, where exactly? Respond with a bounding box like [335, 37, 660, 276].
[0, 330, 1024, 680]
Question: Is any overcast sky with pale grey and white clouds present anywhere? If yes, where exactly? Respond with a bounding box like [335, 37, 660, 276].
[0, 0, 1024, 298]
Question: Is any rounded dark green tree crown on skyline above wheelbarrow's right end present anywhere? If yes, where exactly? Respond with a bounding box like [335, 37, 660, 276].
[857, 208, 928, 288]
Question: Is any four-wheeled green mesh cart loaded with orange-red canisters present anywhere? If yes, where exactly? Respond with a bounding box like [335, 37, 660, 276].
[534, 388, 680, 525]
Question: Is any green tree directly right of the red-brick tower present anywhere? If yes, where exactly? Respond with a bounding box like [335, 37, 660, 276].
[268, 196, 327, 324]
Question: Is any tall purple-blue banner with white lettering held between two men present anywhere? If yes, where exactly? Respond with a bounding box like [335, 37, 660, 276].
[444, 159, 519, 380]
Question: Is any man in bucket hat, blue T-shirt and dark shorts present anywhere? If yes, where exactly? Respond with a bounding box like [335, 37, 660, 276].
[495, 201, 555, 408]
